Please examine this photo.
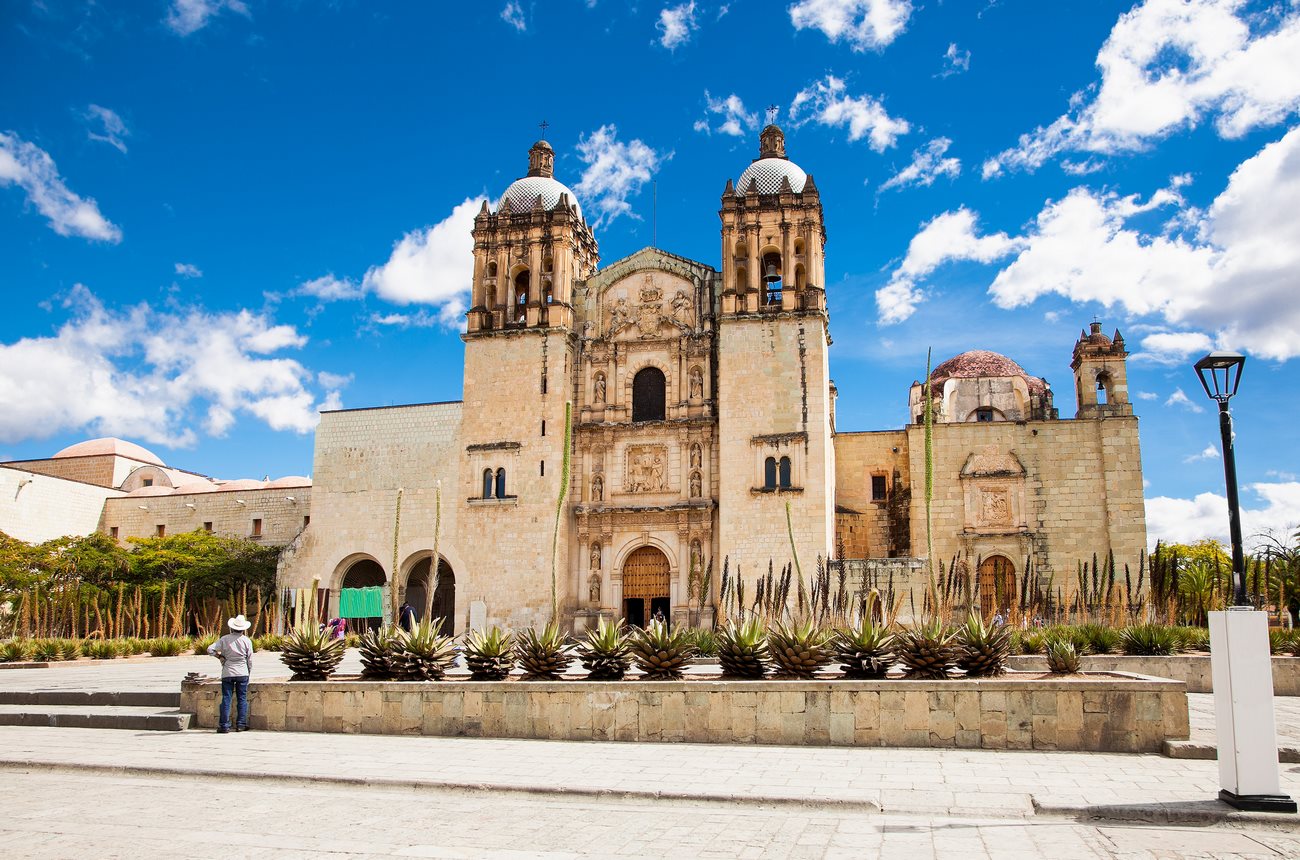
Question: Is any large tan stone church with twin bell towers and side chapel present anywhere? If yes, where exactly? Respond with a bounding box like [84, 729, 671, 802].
[281, 126, 1145, 633]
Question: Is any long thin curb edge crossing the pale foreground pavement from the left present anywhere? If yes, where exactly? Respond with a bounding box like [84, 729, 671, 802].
[0, 759, 880, 812]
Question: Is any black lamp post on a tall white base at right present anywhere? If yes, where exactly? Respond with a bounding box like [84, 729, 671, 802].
[1195, 352, 1296, 812]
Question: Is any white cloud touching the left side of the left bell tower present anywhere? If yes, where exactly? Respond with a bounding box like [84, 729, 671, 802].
[358, 197, 482, 326]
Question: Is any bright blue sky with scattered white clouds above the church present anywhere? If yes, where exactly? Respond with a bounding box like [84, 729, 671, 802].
[0, 0, 1300, 548]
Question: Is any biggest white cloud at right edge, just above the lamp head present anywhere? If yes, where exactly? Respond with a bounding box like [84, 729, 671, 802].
[883, 129, 1300, 360]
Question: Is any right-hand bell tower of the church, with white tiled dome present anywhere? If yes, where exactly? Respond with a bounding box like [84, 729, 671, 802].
[718, 125, 835, 575]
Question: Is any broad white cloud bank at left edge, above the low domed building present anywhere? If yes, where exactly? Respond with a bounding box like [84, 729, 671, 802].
[0, 285, 338, 446]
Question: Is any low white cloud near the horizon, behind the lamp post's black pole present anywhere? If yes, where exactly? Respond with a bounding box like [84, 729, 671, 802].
[1147, 481, 1300, 552]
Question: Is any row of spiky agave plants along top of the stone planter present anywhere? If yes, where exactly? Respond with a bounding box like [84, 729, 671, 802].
[281, 614, 1118, 681]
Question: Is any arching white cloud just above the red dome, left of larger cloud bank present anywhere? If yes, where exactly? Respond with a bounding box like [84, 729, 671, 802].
[876, 207, 1023, 325]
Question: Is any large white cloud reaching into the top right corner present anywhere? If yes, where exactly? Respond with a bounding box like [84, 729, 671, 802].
[984, 0, 1300, 178]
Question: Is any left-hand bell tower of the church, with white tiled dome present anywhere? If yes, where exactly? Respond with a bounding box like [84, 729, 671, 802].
[456, 140, 599, 626]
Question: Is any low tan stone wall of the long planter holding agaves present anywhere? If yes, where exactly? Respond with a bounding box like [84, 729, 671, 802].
[181, 676, 1188, 752]
